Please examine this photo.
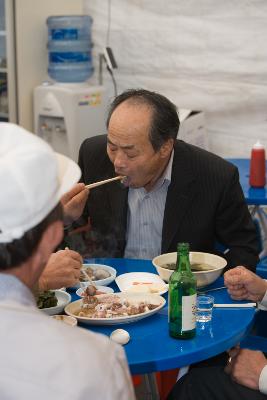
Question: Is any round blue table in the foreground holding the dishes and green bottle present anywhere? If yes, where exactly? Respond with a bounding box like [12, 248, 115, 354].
[72, 259, 255, 374]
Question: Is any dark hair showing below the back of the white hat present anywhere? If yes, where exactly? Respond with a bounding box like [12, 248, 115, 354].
[0, 203, 63, 270]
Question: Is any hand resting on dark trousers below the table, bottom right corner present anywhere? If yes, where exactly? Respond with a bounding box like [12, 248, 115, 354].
[225, 348, 267, 390]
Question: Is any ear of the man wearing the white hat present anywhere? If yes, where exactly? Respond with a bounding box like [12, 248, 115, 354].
[38, 221, 63, 259]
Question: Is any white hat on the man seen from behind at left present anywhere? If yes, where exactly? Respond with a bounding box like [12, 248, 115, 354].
[0, 122, 81, 243]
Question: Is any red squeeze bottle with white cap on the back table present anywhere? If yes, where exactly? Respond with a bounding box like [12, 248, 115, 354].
[249, 141, 266, 188]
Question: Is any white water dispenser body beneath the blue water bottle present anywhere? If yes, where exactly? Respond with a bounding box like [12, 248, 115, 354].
[34, 83, 107, 161]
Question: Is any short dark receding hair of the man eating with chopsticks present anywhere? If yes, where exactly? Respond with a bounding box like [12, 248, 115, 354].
[106, 89, 180, 151]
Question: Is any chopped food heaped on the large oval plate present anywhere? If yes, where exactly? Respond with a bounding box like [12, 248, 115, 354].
[75, 294, 159, 318]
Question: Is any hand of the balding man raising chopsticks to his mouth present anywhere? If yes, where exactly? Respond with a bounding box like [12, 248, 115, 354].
[61, 183, 89, 224]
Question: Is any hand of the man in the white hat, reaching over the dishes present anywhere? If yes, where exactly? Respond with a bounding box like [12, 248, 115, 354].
[39, 250, 82, 290]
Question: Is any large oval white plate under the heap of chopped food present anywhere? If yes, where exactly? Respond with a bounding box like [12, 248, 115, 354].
[65, 293, 166, 325]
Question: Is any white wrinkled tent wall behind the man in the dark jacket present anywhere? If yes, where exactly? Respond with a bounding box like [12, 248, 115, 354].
[84, 0, 267, 157]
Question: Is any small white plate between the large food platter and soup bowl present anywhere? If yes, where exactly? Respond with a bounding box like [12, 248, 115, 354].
[115, 272, 168, 294]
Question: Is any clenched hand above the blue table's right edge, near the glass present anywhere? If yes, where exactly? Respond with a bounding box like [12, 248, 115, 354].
[224, 267, 267, 301]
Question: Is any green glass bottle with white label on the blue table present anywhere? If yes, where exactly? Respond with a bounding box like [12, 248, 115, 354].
[169, 243, 197, 339]
